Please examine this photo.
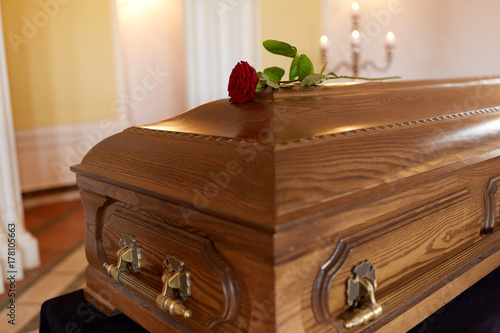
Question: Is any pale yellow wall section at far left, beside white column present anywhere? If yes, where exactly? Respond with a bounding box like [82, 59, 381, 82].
[0, 0, 117, 129]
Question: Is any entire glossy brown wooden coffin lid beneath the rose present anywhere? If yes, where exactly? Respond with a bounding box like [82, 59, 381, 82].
[72, 78, 500, 231]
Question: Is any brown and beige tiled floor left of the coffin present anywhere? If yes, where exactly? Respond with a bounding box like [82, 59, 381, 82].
[0, 200, 87, 333]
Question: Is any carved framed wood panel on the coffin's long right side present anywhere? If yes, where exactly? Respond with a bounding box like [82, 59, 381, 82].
[312, 189, 482, 328]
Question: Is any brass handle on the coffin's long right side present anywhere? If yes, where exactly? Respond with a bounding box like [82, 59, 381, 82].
[342, 261, 382, 329]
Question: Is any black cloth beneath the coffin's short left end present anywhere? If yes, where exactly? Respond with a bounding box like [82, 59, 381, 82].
[40, 289, 148, 333]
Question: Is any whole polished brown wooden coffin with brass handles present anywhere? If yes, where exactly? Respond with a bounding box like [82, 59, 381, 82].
[73, 79, 500, 333]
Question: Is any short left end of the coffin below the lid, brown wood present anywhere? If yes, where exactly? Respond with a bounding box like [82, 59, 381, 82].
[79, 175, 274, 332]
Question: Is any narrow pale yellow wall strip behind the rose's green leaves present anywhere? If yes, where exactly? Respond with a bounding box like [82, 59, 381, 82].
[257, 0, 322, 79]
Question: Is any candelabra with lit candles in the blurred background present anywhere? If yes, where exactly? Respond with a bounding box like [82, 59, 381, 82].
[320, 2, 396, 76]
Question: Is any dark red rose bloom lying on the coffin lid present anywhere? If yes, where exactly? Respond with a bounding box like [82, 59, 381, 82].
[227, 61, 259, 104]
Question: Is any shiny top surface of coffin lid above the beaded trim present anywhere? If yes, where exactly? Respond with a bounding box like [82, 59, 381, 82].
[142, 79, 500, 144]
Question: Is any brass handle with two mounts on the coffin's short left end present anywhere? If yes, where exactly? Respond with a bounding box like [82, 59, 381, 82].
[103, 235, 193, 318]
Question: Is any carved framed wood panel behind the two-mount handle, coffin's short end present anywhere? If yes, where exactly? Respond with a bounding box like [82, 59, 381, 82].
[102, 204, 240, 329]
